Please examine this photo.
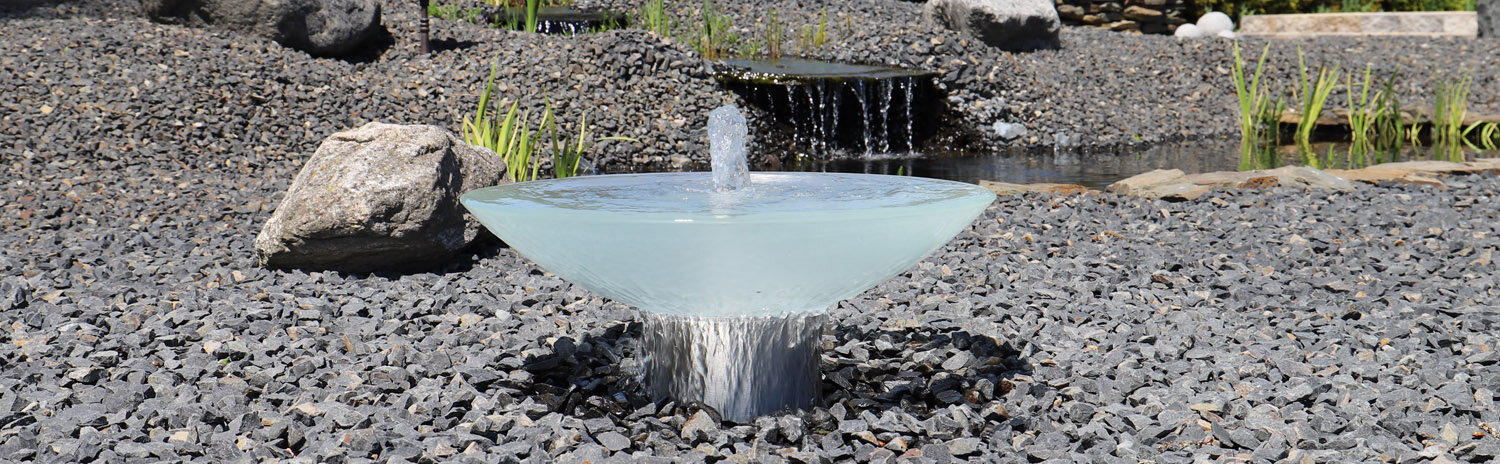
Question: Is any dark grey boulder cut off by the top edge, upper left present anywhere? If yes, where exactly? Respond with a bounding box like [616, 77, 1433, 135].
[141, 0, 381, 57]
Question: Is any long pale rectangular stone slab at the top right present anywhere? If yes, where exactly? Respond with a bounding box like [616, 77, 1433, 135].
[1239, 12, 1479, 39]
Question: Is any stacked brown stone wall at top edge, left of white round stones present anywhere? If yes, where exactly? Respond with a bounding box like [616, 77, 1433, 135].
[1055, 0, 1188, 35]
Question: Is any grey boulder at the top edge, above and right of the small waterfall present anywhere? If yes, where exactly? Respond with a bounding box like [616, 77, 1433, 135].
[923, 0, 1062, 51]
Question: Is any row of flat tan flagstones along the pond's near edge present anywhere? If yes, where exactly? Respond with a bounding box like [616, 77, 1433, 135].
[980, 158, 1500, 201]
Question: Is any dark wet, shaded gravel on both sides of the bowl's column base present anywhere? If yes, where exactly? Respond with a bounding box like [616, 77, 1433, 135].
[503, 321, 1029, 422]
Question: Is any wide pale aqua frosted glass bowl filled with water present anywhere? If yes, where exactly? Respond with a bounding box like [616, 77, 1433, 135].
[462, 173, 995, 317]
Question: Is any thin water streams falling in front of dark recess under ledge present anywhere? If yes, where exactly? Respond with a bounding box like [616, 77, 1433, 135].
[717, 60, 944, 158]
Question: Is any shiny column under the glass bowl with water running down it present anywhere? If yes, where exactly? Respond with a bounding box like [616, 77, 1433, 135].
[642, 311, 828, 422]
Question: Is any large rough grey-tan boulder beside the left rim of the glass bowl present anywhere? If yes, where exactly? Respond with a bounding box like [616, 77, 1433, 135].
[255, 123, 506, 272]
